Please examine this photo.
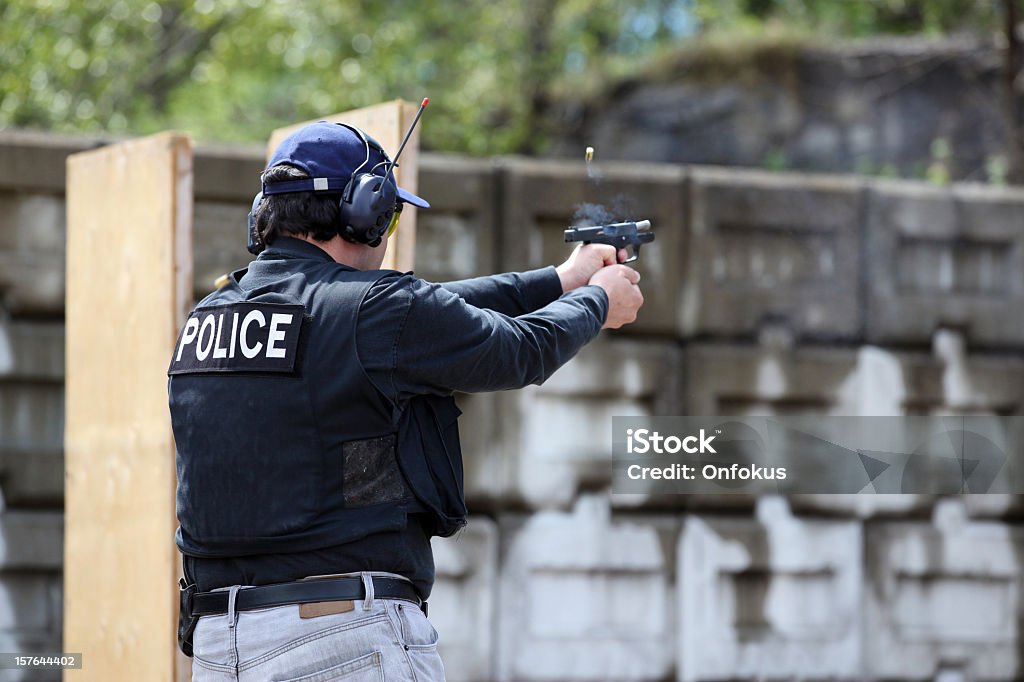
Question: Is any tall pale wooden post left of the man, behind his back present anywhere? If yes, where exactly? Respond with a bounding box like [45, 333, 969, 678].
[63, 133, 193, 682]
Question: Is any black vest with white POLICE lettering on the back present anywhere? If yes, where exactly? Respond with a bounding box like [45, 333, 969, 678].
[168, 259, 466, 557]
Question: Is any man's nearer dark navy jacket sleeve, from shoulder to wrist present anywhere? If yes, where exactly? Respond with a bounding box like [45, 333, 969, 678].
[357, 275, 608, 402]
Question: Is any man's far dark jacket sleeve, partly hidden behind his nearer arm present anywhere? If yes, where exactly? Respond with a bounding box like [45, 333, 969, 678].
[440, 266, 562, 317]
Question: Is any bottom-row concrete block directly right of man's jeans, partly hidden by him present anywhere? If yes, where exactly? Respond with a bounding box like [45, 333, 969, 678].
[430, 516, 498, 682]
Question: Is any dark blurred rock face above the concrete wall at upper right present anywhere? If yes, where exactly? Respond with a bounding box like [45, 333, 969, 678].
[551, 39, 1007, 180]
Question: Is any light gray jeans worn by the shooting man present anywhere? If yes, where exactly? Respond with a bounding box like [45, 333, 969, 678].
[193, 573, 444, 682]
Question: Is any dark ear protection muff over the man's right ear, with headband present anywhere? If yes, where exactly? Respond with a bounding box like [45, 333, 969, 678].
[338, 123, 398, 247]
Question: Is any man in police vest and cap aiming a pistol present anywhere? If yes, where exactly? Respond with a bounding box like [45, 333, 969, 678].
[168, 122, 643, 682]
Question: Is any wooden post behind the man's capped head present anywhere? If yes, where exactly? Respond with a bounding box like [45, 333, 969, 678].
[266, 99, 429, 272]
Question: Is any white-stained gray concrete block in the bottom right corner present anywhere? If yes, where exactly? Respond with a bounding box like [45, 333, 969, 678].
[864, 500, 1024, 680]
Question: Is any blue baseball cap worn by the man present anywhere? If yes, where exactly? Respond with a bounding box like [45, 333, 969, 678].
[263, 121, 430, 208]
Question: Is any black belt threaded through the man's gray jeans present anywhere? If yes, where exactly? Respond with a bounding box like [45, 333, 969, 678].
[189, 577, 417, 615]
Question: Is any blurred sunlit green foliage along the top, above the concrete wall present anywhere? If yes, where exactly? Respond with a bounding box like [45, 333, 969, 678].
[0, 0, 998, 155]
